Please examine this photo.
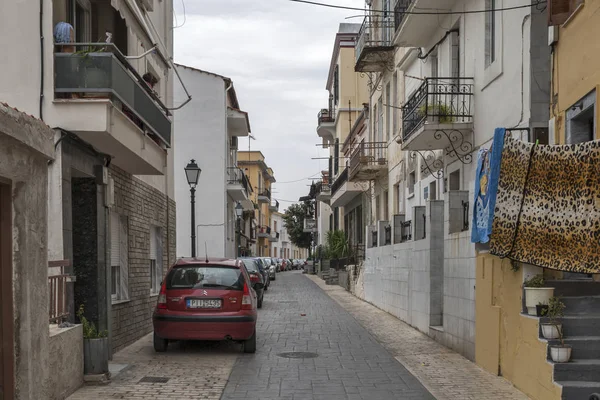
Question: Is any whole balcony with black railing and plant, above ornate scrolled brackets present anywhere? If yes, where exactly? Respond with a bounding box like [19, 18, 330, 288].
[402, 78, 473, 150]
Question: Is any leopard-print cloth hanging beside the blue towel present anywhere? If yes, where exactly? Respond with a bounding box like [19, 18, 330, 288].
[490, 135, 600, 273]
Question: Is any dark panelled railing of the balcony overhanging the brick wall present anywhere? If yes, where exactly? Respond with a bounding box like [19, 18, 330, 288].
[54, 43, 171, 146]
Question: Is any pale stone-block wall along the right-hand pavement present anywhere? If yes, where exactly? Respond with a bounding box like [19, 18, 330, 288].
[358, 200, 475, 360]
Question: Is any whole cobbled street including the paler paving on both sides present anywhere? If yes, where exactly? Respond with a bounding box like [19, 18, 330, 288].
[69, 272, 527, 400]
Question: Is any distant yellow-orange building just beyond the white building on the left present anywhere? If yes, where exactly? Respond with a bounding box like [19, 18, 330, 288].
[238, 151, 276, 257]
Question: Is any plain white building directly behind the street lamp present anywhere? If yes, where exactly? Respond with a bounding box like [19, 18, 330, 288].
[175, 65, 254, 257]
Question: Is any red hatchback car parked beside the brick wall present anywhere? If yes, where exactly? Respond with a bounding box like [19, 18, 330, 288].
[152, 258, 262, 353]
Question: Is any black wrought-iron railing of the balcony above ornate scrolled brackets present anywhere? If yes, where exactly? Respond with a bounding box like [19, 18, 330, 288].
[402, 78, 473, 140]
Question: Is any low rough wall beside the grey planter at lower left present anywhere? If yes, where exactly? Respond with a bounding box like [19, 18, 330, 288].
[48, 325, 83, 400]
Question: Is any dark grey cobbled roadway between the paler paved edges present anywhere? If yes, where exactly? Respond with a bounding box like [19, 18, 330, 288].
[222, 272, 434, 400]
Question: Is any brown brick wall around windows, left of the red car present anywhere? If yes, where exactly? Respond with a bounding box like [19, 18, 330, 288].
[110, 167, 176, 352]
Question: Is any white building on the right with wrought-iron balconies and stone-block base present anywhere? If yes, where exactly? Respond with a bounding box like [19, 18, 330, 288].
[356, 0, 550, 360]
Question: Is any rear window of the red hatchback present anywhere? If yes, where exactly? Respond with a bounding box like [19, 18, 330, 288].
[166, 264, 244, 290]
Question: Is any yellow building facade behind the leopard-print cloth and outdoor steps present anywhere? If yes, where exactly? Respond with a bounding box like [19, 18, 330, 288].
[475, 4, 600, 400]
